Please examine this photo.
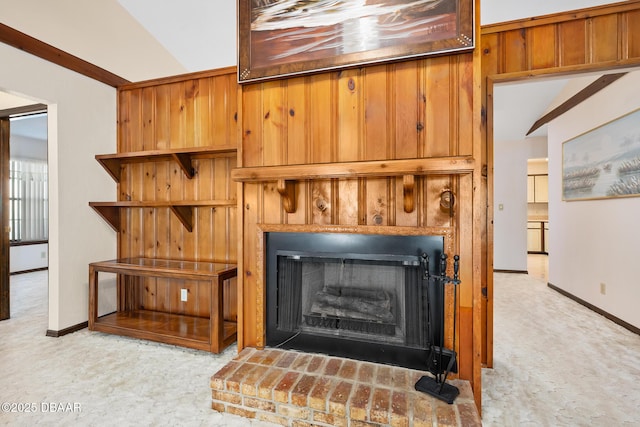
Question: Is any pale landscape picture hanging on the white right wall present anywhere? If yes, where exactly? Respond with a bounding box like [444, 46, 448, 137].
[562, 109, 640, 201]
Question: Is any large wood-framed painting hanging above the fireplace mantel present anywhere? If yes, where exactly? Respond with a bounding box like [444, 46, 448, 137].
[238, 0, 475, 83]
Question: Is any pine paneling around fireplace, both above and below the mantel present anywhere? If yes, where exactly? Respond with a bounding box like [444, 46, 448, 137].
[239, 49, 480, 395]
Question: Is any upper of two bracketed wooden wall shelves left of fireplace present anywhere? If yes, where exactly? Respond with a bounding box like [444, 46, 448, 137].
[96, 145, 237, 183]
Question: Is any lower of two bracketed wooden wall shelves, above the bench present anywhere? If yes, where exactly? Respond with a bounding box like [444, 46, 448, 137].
[89, 200, 237, 232]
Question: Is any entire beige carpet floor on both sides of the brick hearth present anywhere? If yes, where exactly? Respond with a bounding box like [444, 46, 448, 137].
[0, 272, 640, 427]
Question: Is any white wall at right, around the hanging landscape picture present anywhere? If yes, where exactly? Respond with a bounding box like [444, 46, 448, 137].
[548, 71, 640, 327]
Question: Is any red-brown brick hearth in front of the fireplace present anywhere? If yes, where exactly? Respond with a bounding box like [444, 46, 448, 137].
[211, 348, 482, 427]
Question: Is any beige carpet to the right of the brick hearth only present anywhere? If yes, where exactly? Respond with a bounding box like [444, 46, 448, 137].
[482, 274, 640, 427]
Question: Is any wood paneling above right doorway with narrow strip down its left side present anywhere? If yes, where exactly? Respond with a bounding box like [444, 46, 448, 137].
[480, 0, 640, 367]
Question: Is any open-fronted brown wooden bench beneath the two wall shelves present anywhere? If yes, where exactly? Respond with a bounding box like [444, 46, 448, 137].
[89, 258, 237, 353]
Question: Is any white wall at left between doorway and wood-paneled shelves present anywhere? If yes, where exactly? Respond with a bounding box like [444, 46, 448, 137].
[0, 43, 116, 331]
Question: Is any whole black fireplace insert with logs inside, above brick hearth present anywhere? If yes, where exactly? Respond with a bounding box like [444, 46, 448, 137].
[265, 232, 444, 371]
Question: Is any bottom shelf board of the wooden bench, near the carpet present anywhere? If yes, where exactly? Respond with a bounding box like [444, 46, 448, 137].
[93, 310, 237, 351]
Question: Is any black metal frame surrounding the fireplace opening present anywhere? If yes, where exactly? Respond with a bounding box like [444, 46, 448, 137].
[265, 232, 445, 370]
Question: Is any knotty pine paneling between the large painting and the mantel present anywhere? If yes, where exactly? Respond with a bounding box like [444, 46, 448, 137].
[240, 54, 473, 167]
